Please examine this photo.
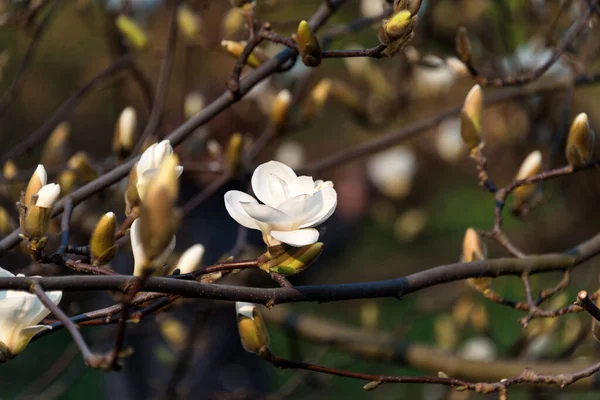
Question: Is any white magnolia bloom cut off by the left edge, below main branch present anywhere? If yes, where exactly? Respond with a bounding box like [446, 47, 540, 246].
[0, 268, 62, 363]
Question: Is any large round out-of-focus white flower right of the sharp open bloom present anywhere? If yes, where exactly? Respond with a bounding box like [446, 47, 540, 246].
[367, 147, 417, 199]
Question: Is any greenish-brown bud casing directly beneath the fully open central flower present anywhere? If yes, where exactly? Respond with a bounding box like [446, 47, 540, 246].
[258, 242, 323, 275]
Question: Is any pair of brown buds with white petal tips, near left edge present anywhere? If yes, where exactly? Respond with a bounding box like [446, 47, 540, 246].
[17, 164, 60, 251]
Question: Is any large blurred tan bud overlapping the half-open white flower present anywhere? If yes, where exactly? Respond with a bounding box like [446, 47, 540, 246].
[139, 155, 180, 261]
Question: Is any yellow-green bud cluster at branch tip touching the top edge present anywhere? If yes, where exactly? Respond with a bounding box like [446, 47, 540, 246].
[378, 0, 422, 57]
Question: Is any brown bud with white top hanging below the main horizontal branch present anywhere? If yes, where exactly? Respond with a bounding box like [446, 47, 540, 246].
[235, 301, 270, 354]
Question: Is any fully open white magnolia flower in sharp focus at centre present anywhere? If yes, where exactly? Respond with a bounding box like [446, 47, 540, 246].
[225, 161, 337, 247]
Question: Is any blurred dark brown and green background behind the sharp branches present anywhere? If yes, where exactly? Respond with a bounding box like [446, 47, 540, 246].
[0, 0, 600, 400]
